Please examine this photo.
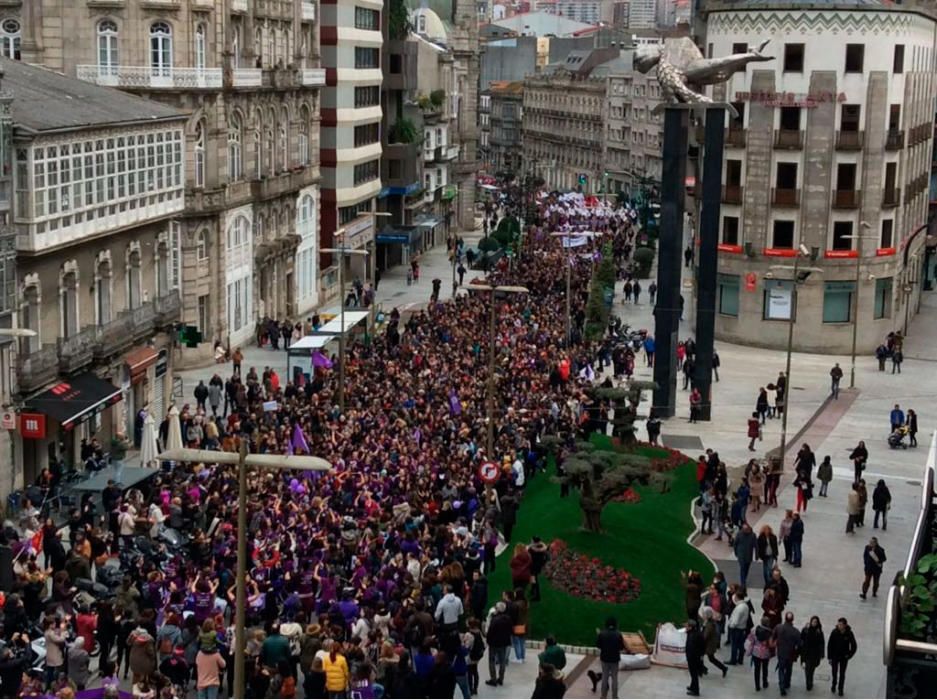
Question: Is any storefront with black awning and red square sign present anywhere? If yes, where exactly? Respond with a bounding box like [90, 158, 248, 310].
[20, 372, 123, 483]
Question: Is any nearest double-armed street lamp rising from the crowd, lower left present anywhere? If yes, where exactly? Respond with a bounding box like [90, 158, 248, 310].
[159, 446, 332, 698]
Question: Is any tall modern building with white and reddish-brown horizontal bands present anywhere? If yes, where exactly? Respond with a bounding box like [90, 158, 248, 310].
[320, 0, 384, 289]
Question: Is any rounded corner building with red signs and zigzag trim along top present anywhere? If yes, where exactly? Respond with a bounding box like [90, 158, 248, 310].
[704, 2, 937, 353]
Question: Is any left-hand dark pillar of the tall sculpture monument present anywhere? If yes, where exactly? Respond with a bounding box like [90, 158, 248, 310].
[654, 107, 689, 418]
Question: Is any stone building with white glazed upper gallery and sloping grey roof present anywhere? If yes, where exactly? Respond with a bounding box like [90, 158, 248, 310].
[0, 58, 187, 489]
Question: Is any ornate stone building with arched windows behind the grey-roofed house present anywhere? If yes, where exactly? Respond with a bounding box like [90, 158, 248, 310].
[20, 0, 325, 364]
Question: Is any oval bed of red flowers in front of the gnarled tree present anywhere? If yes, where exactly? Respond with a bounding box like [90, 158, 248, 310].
[543, 540, 641, 604]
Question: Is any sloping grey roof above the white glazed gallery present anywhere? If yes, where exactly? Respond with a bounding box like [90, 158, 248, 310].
[0, 57, 186, 132]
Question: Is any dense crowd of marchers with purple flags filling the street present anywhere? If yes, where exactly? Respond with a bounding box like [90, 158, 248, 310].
[0, 191, 633, 698]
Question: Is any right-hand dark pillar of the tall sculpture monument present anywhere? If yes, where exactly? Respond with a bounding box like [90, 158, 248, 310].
[694, 107, 726, 420]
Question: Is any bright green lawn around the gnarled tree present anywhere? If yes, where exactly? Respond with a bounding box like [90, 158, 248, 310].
[489, 436, 712, 646]
